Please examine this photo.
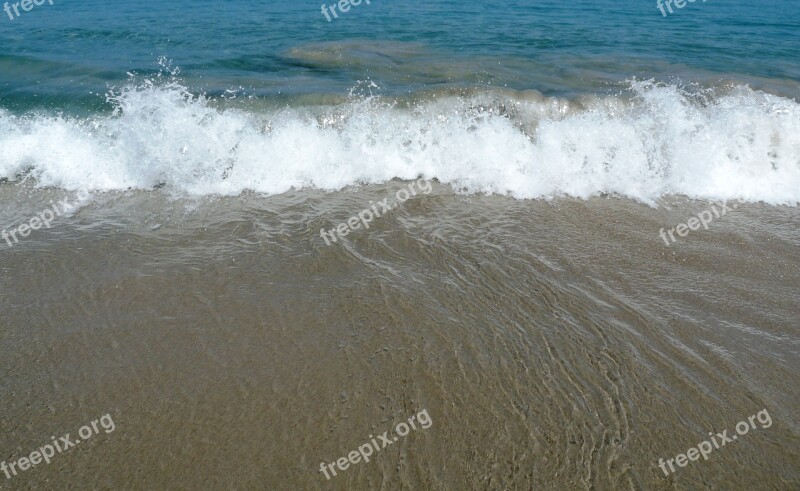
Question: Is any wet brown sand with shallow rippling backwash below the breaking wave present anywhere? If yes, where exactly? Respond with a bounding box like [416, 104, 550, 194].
[0, 181, 800, 489]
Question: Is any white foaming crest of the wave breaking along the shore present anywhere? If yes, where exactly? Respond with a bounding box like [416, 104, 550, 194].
[0, 81, 800, 205]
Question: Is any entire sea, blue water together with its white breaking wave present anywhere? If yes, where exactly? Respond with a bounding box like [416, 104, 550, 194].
[0, 0, 800, 204]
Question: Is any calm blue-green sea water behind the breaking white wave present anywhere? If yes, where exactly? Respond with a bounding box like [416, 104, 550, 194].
[0, 0, 800, 109]
